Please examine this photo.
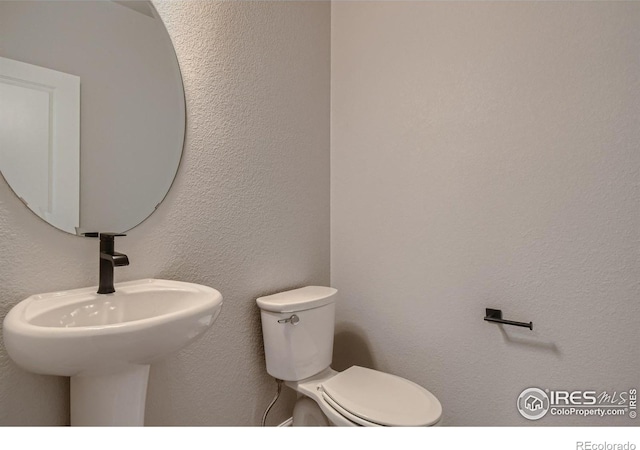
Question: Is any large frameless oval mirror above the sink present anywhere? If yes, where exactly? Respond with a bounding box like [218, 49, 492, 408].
[0, 0, 185, 235]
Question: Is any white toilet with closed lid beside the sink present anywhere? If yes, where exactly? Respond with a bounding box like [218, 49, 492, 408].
[257, 286, 442, 426]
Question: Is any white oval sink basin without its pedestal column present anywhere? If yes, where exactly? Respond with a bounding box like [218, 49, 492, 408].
[4, 279, 222, 376]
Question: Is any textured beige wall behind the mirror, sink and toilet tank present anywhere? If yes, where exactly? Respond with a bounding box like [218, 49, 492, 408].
[0, 1, 330, 425]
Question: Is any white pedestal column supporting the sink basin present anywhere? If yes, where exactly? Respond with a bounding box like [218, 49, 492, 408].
[71, 365, 150, 427]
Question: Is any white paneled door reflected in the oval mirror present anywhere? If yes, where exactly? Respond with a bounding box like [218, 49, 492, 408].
[0, 57, 80, 234]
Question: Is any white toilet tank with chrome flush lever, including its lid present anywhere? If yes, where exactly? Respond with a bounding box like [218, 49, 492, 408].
[256, 286, 338, 381]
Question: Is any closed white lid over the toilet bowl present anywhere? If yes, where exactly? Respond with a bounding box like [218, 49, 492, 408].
[322, 366, 442, 426]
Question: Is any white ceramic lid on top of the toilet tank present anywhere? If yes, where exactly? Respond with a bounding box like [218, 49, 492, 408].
[256, 286, 338, 312]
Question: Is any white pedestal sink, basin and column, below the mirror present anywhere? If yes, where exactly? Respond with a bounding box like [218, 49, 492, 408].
[3, 279, 222, 426]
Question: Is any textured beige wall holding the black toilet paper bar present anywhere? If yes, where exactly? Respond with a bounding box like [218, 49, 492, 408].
[331, 2, 640, 425]
